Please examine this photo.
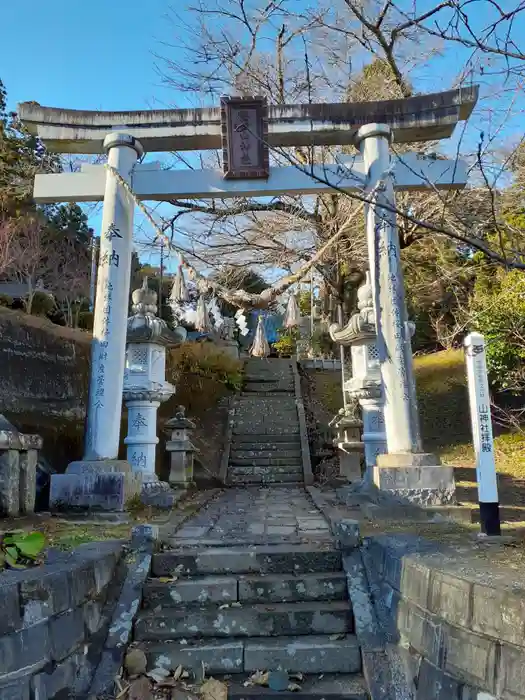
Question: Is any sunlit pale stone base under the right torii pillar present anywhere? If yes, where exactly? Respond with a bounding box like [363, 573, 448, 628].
[372, 453, 456, 506]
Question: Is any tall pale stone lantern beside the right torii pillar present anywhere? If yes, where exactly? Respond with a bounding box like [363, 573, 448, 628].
[330, 273, 387, 476]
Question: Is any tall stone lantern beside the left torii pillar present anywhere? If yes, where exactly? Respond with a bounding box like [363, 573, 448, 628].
[123, 278, 186, 500]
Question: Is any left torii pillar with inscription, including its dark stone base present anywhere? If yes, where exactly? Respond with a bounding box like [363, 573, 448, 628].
[50, 131, 143, 510]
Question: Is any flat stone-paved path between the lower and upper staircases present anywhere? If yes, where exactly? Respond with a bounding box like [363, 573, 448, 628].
[170, 486, 331, 546]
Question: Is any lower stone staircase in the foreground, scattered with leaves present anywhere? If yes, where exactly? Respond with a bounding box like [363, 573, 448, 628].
[134, 538, 368, 700]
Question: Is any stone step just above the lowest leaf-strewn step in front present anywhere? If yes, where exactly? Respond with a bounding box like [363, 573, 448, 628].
[140, 634, 361, 672]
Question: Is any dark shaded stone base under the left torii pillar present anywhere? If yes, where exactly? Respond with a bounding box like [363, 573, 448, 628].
[49, 459, 142, 512]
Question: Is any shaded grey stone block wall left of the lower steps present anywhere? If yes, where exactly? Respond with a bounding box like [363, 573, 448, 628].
[0, 542, 124, 700]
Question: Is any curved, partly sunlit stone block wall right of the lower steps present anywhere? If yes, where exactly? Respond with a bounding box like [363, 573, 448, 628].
[362, 535, 525, 700]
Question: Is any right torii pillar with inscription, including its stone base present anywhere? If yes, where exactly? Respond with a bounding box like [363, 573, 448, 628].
[357, 124, 455, 505]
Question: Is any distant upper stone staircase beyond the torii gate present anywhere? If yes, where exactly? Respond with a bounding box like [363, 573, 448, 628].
[227, 358, 310, 485]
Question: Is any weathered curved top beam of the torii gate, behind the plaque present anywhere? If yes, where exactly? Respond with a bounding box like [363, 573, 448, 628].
[18, 86, 478, 153]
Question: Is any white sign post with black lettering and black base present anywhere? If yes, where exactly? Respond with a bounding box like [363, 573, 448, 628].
[464, 333, 501, 535]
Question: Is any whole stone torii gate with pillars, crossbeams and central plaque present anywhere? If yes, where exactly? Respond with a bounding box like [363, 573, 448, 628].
[18, 87, 478, 508]
